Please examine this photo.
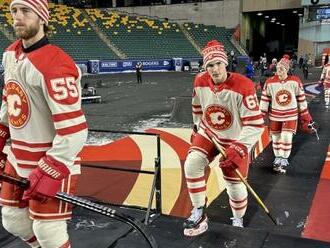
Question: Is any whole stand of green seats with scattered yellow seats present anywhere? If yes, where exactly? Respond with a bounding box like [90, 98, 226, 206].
[0, 0, 239, 61]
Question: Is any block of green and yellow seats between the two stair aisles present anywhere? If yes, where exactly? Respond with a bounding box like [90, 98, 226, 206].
[86, 9, 200, 59]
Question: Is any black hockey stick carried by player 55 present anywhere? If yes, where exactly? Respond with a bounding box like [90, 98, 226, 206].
[0, 173, 158, 248]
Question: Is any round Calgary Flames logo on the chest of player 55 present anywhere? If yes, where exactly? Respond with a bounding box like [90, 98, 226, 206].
[6, 81, 30, 128]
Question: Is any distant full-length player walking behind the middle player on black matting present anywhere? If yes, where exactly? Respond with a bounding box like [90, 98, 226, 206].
[260, 57, 312, 174]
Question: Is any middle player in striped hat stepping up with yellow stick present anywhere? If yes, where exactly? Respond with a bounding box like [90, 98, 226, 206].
[183, 40, 264, 236]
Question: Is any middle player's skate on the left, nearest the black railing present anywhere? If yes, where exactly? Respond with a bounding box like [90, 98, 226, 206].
[183, 207, 208, 237]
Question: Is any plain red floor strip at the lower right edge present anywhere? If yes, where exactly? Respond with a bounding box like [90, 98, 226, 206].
[302, 146, 330, 242]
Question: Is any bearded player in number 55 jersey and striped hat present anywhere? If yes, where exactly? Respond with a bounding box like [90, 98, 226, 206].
[0, 0, 87, 248]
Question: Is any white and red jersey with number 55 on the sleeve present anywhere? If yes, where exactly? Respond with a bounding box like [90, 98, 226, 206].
[0, 41, 87, 177]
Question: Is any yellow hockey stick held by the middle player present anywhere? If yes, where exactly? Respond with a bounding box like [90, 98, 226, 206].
[205, 135, 277, 226]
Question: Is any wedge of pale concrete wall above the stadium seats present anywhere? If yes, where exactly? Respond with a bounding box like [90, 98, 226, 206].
[114, 0, 240, 28]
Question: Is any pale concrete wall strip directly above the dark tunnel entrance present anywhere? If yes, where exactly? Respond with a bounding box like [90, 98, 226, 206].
[241, 0, 301, 12]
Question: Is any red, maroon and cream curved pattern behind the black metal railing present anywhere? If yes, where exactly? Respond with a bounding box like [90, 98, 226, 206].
[78, 128, 269, 216]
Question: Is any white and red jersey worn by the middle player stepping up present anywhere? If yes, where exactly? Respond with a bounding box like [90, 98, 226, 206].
[192, 72, 264, 151]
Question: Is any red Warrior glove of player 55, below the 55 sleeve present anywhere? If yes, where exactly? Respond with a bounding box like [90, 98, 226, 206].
[23, 156, 70, 201]
